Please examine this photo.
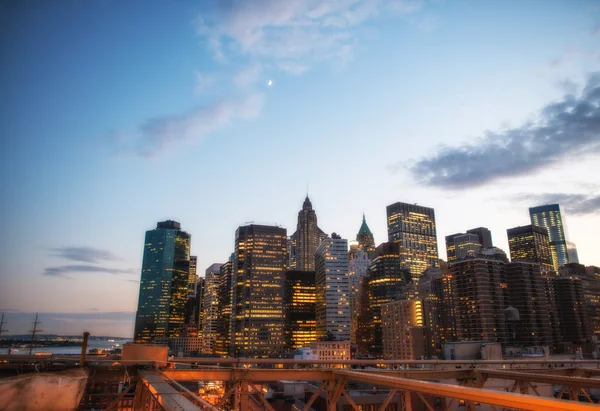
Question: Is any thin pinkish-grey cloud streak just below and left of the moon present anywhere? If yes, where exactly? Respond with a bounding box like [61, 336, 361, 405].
[117, 93, 264, 157]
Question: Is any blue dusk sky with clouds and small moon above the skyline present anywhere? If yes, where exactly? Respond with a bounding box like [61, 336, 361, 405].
[0, 0, 600, 337]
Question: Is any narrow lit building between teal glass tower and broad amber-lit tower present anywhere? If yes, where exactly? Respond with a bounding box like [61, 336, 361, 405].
[202, 263, 223, 354]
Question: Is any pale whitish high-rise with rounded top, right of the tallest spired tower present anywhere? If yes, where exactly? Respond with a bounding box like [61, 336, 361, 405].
[315, 233, 350, 341]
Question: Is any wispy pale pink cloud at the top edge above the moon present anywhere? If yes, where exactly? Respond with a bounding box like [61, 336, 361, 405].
[196, 0, 421, 66]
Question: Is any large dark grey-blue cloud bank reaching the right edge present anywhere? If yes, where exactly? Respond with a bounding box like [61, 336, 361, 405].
[406, 73, 600, 189]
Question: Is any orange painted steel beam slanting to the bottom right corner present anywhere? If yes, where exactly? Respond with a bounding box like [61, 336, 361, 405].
[333, 370, 598, 411]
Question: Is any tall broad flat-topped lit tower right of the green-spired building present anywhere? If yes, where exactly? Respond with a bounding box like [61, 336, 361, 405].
[387, 203, 438, 280]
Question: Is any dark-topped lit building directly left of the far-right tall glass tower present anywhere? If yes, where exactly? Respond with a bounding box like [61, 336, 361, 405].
[506, 225, 554, 273]
